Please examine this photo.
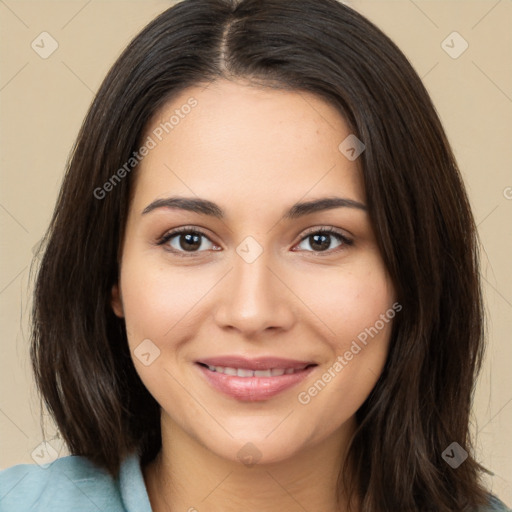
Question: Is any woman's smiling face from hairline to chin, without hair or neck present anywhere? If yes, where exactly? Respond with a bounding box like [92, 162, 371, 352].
[112, 81, 397, 462]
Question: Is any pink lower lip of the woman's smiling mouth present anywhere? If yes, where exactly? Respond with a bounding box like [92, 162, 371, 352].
[198, 365, 314, 402]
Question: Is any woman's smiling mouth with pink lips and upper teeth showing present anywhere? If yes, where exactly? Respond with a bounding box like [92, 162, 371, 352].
[196, 356, 318, 402]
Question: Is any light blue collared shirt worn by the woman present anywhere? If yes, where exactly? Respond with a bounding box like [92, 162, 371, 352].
[0, 454, 512, 512]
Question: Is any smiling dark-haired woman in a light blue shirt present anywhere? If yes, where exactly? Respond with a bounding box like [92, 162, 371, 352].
[0, 0, 507, 512]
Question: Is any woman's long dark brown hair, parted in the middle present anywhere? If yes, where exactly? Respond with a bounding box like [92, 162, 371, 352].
[31, 0, 485, 512]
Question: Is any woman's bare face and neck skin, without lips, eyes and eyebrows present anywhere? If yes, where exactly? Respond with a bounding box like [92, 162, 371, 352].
[112, 80, 395, 512]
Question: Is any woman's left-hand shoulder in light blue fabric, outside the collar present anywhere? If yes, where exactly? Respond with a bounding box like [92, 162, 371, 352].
[0, 455, 123, 512]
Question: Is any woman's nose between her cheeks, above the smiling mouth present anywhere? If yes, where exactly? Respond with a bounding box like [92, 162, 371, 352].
[215, 252, 296, 338]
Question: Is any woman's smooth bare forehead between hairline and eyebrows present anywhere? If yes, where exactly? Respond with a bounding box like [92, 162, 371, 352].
[134, 80, 364, 216]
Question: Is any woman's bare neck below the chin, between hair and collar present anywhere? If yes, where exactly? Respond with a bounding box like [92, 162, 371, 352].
[143, 413, 358, 512]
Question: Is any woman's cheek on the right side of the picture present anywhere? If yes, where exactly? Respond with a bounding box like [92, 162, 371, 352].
[290, 258, 394, 420]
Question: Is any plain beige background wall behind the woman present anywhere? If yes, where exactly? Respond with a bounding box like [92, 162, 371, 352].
[0, 0, 512, 505]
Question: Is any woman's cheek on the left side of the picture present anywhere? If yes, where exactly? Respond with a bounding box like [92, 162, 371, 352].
[120, 254, 208, 416]
